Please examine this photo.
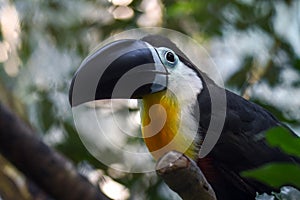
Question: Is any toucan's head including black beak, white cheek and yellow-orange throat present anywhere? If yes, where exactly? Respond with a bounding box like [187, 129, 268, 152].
[69, 35, 204, 158]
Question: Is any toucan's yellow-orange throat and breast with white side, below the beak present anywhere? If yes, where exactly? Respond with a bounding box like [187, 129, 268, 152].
[141, 90, 197, 159]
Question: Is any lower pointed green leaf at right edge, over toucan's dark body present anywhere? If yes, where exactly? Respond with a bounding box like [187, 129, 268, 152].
[241, 163, 300, 188]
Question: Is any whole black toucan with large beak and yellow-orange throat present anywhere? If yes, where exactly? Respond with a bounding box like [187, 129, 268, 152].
[69, 35, 300, 200]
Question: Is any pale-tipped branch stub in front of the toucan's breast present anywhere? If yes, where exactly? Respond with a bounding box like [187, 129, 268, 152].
[156, 151, 217, 200]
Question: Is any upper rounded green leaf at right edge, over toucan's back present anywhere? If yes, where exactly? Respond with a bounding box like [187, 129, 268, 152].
[266, 127, 300, 157]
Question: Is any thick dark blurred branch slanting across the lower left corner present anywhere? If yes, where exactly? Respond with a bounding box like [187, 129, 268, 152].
[0, 103, 109, 200]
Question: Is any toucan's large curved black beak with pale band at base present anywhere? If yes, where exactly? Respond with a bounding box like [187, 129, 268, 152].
[69, 40, 168, 107]
